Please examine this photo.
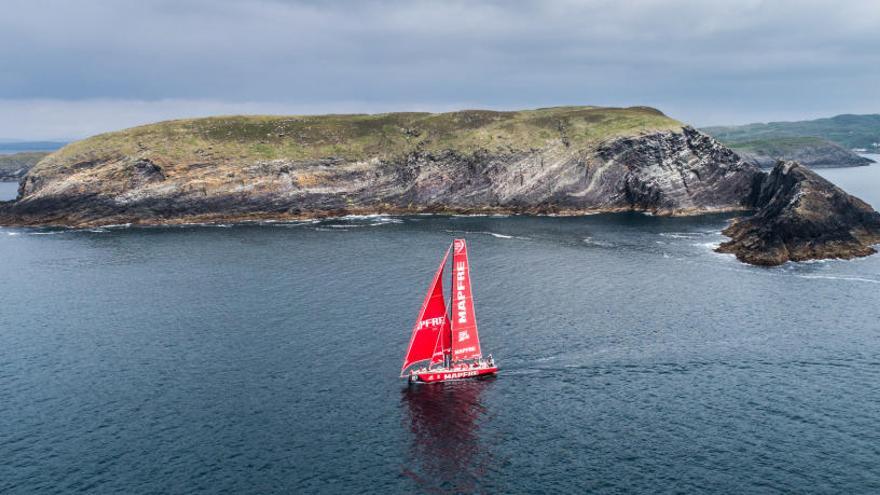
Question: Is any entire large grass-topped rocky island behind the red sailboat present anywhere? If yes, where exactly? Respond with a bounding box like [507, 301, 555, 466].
[0, 107, 759, 226]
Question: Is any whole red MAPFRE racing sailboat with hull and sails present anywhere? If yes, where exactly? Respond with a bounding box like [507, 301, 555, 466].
[400, 239, 498, 383]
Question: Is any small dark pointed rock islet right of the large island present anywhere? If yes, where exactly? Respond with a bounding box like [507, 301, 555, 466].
[718, 161, 880, 266]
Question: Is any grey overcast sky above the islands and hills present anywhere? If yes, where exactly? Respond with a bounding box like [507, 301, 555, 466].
[0, 0, 880, 139]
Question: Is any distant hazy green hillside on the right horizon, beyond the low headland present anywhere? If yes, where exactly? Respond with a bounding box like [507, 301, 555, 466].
[702, 114, 880, 150]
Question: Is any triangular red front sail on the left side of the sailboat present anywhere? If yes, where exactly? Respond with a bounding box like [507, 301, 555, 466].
[400, 249, 449, 376]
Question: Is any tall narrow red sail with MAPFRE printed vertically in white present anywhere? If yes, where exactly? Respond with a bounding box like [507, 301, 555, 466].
[450, 239, 482, 361]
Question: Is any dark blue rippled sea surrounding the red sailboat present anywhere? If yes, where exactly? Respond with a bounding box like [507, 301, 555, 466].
[0, 161, 880, 494]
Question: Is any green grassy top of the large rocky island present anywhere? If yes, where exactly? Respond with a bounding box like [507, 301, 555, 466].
[47, 107, 682, 167]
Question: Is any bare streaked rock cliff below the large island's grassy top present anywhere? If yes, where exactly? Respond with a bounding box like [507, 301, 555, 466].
[0, 122, 760, 226]
